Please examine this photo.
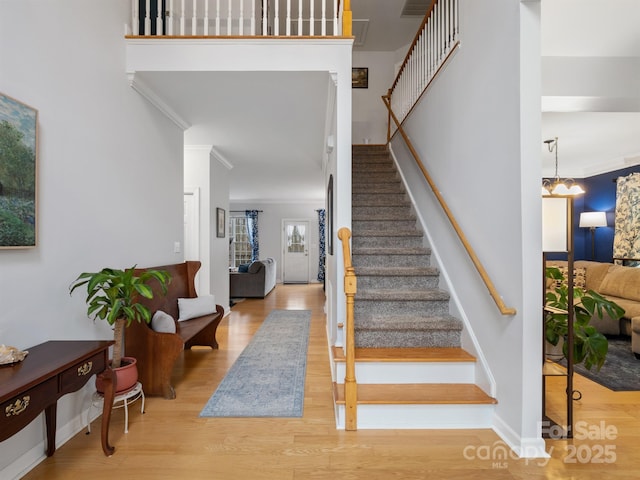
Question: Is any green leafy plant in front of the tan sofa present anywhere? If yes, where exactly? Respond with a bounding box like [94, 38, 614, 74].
[544, 267, 624, 370]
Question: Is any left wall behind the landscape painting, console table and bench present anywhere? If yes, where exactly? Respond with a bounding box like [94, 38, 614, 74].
[0, 0, 183, 478]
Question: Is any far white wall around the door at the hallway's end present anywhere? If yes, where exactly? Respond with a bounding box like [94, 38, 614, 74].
[229, 200, 325, 283]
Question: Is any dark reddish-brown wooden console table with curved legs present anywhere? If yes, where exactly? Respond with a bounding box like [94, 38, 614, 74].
[0, 340, 115, 456]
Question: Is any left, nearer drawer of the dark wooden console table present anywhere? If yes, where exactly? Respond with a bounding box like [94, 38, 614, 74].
[0, 377, 58, 441]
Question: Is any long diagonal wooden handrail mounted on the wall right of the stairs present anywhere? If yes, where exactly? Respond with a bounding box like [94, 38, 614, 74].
[382, 95, 516, 315]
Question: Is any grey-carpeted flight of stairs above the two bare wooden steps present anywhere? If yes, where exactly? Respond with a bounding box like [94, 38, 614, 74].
[352, 145, 462, 348]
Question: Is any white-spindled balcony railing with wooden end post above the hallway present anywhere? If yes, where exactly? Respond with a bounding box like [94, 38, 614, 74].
[128, 0, 352, 38]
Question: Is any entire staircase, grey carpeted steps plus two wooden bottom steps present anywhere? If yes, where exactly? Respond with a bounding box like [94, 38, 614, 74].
[332, 145, 496, 429]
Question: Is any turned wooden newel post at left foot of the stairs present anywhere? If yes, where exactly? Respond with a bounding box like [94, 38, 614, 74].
[338, 227, 358, 431]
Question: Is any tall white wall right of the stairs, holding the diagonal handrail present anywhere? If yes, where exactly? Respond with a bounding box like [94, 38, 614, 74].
[393, 0, 544, 455]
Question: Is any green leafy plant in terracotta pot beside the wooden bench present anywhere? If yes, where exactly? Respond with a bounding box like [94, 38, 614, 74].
[69, 265, 171, 392]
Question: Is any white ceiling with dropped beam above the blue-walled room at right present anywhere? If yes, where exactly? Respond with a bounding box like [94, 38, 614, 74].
[540, 0, 640, 178]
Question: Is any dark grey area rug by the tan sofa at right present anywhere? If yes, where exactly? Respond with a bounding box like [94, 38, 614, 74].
[574, 336, 640, 392]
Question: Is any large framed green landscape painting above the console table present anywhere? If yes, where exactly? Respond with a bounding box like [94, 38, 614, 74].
[0, 93, 38, 248]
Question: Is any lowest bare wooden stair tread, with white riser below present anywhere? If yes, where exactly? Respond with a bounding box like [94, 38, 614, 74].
[334, 383, 498, 405]
